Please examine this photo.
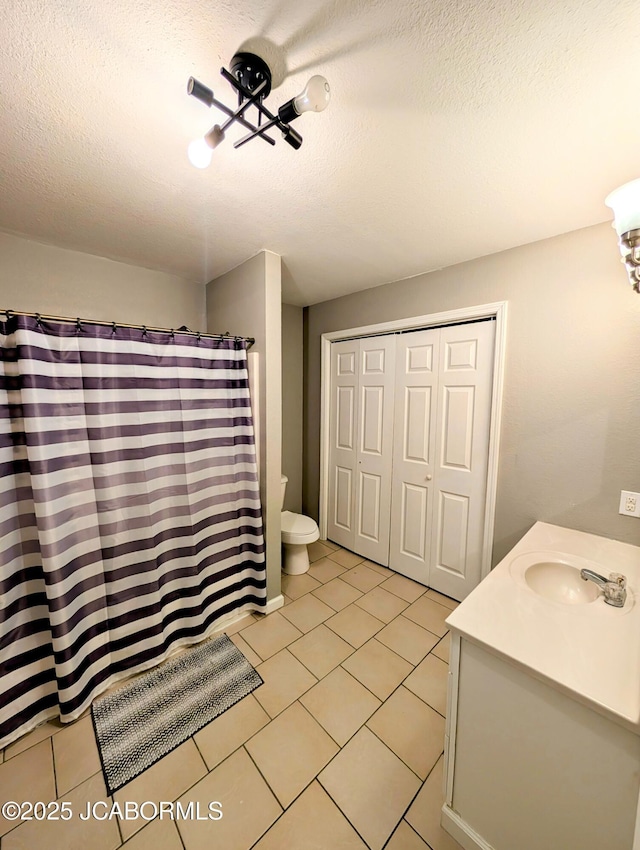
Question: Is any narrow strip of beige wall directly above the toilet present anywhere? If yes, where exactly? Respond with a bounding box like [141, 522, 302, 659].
[282, 304, 304, 513]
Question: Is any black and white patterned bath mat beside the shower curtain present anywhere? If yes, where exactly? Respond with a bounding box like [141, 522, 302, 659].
[91, 634, 263, 794]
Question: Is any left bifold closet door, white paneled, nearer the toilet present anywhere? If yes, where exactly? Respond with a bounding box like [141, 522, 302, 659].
[328, 336, 395, 566]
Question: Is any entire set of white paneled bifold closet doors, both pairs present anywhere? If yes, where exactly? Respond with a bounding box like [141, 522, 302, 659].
[328, 321, 495, 599]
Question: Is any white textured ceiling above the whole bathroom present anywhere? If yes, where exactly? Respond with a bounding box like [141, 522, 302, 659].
[0, 0, 640, 305]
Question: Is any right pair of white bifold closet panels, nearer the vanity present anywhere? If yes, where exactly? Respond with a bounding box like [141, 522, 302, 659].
[389, 321, 495, 599]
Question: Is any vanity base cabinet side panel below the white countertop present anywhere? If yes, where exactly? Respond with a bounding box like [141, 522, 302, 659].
[443, 635, 640, 850]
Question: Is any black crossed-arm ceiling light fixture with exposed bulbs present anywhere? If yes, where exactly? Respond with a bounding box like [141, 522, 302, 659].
[187, 53, 331, 168]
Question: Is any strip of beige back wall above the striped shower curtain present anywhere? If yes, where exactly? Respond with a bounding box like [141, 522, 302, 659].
[0, 233, 205, 331]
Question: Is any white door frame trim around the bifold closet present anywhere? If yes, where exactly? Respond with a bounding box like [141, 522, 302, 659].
[318, 301, 508, 579]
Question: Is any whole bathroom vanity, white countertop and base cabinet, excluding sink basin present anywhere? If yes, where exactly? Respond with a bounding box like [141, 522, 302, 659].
[442, 523, 640, 850]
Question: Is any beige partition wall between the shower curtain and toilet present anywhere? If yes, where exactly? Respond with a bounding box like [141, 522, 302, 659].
[207, 251, 282, 600]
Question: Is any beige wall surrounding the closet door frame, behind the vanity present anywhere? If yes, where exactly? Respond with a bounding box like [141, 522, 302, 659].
[303, 224, 640, 562]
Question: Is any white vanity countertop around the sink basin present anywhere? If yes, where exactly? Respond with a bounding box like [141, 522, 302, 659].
[447, 522, 640, 734]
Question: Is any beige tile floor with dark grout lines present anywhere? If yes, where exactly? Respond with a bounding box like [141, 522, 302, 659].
[0, 541, 459, 850]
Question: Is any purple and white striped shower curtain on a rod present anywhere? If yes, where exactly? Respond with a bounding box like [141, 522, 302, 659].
[0, 316, 266, 748]
